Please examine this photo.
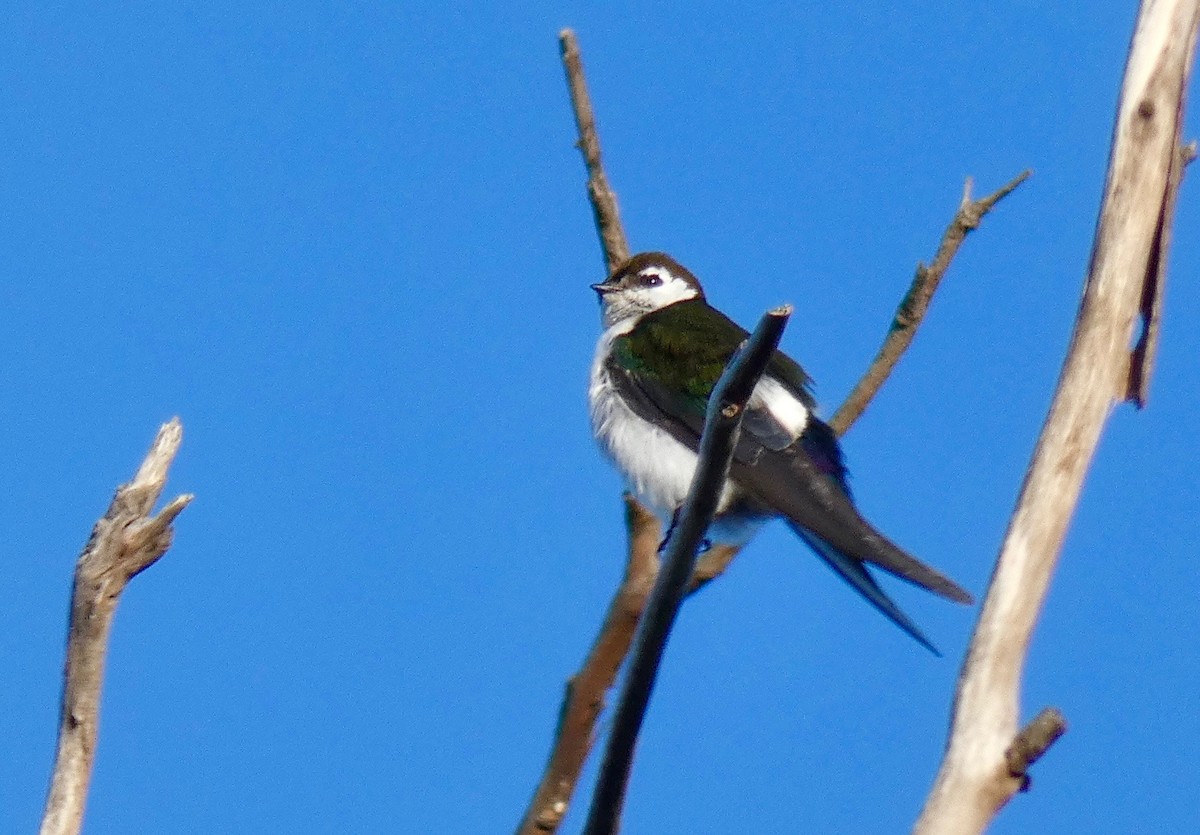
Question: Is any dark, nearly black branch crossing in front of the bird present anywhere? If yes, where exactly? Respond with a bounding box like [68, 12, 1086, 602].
[583, 306, 792, 835]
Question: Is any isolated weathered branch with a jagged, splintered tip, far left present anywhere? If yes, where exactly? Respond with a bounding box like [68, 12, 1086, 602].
[41, 418, 192, 835]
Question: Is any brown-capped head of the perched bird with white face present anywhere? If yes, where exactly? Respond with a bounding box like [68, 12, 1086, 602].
[592, 252, 704, 328]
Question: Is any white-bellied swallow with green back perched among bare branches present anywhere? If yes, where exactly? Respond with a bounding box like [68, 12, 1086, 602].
[588, 252, 972, 654]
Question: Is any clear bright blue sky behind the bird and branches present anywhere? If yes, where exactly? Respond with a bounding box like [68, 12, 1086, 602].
[0, 0, 1200, 835]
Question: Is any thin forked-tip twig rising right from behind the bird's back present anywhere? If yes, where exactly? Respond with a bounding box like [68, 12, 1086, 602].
[829, 170, 1032, 435]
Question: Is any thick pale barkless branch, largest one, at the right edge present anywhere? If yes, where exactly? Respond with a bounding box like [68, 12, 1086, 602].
[916, 0, 1200, 835]
